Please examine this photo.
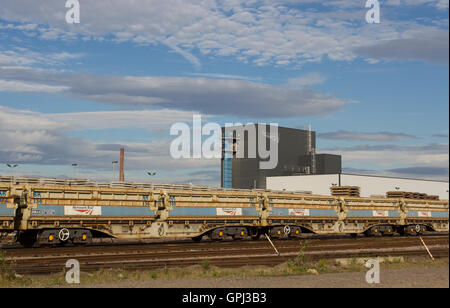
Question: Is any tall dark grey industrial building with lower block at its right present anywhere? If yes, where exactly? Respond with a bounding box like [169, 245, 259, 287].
[221, 124, 342, 189]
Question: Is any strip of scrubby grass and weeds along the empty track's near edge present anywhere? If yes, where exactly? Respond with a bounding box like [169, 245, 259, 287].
[0, 249, 448, 287]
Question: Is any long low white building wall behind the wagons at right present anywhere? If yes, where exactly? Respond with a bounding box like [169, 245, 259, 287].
[267, 174, 449, 200]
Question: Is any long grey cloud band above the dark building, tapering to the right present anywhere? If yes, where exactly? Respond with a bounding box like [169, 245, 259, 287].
[0, 66, 354, 118]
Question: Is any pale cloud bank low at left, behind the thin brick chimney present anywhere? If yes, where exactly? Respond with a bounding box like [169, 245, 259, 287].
[0, 106, 216, 171]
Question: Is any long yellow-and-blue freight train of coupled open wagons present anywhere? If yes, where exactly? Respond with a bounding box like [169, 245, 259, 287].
[0, 179, 449, 246]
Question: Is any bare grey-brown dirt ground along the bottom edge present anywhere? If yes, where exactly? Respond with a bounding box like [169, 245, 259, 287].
[75, 266, 449, 288]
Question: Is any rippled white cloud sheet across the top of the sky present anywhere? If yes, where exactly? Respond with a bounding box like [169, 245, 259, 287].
[0, 0, 448, 68]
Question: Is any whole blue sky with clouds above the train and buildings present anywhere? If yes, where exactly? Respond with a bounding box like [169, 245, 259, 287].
[0, 0, 449, 186]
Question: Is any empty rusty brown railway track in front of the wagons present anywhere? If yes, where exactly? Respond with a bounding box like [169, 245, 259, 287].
[4, 234, 449, 274]
